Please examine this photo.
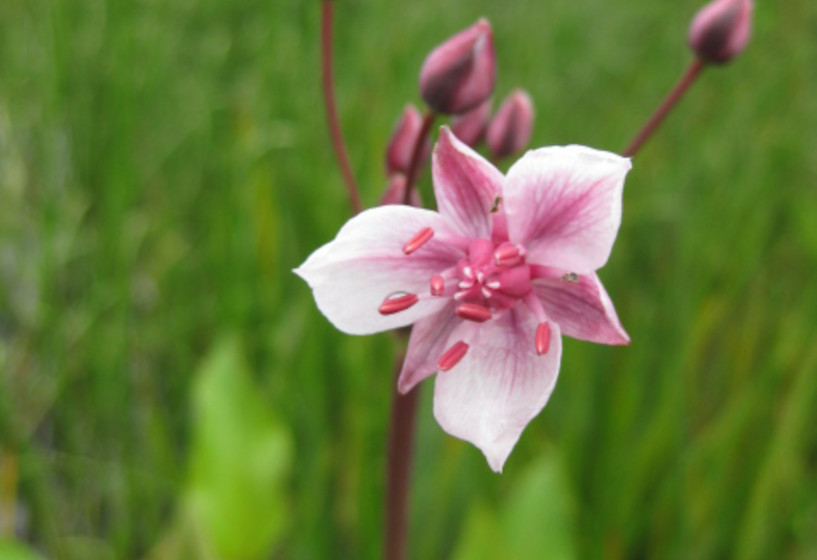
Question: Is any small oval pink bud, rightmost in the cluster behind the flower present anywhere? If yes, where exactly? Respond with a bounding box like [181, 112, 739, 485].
[485, 89, 533, 159]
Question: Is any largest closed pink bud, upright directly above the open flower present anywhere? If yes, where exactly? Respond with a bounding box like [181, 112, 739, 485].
[420, 19, 496, 115]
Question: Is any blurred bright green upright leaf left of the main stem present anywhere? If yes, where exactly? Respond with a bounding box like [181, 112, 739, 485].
[185, 337, 292, 559]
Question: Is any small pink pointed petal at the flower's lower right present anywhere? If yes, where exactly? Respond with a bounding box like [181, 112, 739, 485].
[533, 269, 630, 345]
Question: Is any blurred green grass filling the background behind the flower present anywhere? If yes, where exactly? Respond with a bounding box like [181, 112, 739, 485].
[0, 0, 817, 559]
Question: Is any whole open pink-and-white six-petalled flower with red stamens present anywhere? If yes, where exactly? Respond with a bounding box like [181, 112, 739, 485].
[295, 127, 630, 472]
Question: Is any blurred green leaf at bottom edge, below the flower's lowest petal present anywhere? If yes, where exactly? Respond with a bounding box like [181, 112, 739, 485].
[453, 453, 576, 560]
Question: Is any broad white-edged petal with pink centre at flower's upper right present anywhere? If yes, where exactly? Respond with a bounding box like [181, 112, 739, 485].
[503, 146, 631, 273]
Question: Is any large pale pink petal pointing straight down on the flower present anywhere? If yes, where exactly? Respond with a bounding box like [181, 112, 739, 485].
[434, 305, 562, 472]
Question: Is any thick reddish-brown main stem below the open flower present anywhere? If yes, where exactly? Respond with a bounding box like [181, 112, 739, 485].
[385, 355, 420, 560]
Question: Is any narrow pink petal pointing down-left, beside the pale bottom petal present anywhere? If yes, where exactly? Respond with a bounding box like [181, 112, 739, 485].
[397, 299, 462, 395]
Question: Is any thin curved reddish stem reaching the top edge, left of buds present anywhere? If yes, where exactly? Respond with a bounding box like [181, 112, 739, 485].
[321, 0, 363, 214]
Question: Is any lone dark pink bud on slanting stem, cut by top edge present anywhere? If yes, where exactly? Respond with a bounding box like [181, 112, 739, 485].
[689, 0, 752, 64]
